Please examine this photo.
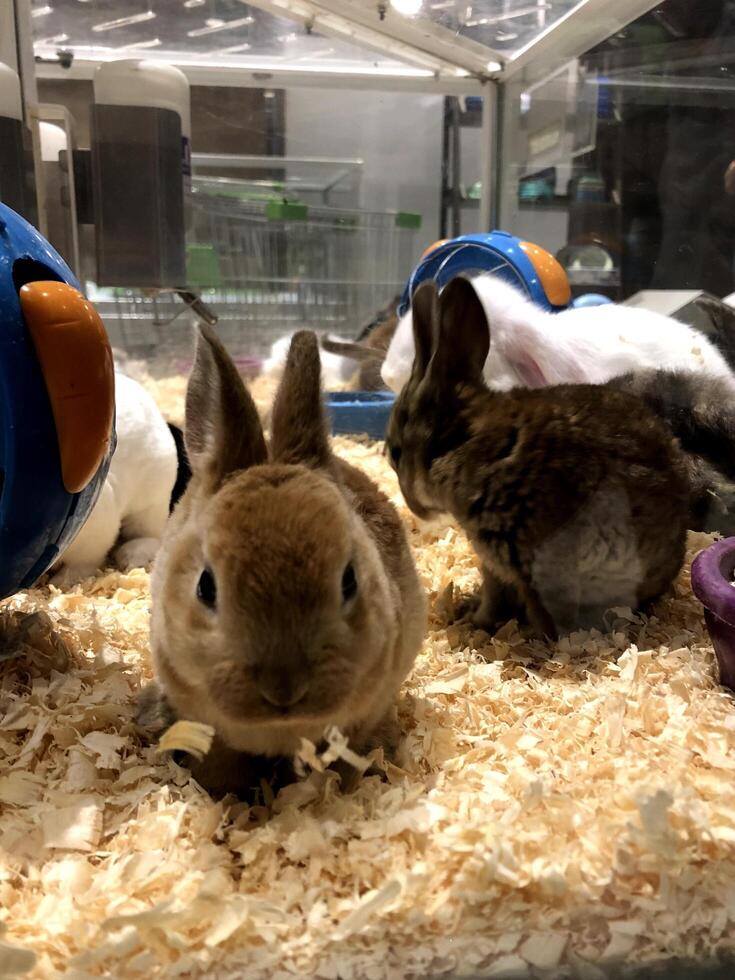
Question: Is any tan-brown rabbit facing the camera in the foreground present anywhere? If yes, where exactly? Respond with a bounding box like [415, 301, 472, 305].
[142, 327, 426, 788]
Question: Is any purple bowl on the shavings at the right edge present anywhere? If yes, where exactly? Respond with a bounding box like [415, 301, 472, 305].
[692, 538, 735, 691]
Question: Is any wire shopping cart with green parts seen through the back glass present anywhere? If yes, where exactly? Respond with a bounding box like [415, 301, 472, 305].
[98, 178, 421, 362]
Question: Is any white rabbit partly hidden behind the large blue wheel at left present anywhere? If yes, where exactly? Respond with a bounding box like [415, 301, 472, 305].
[51, 371, 178, 588]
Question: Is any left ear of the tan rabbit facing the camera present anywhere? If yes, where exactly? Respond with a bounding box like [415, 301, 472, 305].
[184, 325, 268, 487]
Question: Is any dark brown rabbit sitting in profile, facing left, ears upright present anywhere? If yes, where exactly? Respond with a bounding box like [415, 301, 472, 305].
[386, 278, 689, 637]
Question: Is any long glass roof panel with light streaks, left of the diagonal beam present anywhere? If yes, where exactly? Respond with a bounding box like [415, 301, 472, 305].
[33, 0, 405, 70]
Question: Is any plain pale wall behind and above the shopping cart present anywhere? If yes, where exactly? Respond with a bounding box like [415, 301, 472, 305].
[286, 88, 442, 244]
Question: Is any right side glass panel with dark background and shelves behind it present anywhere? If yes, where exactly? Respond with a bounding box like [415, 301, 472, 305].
[501, 0, 735, 302]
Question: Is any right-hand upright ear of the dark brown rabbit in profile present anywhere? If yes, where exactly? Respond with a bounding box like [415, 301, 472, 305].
[431, 276, 490, 382]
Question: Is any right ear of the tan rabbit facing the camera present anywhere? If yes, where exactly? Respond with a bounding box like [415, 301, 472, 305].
[271, 330, 331, 468]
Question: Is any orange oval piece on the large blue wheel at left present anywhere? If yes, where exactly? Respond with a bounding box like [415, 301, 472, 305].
[19, 282, 115, 493]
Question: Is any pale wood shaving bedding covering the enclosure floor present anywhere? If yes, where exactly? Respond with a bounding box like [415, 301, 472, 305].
[0, 379, 735, 980]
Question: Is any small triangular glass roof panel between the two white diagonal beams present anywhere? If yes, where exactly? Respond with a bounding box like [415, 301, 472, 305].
[422, 0, 578, 57]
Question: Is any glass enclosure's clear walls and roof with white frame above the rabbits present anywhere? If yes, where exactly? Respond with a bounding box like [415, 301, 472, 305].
[27, 0, 735, 362]
